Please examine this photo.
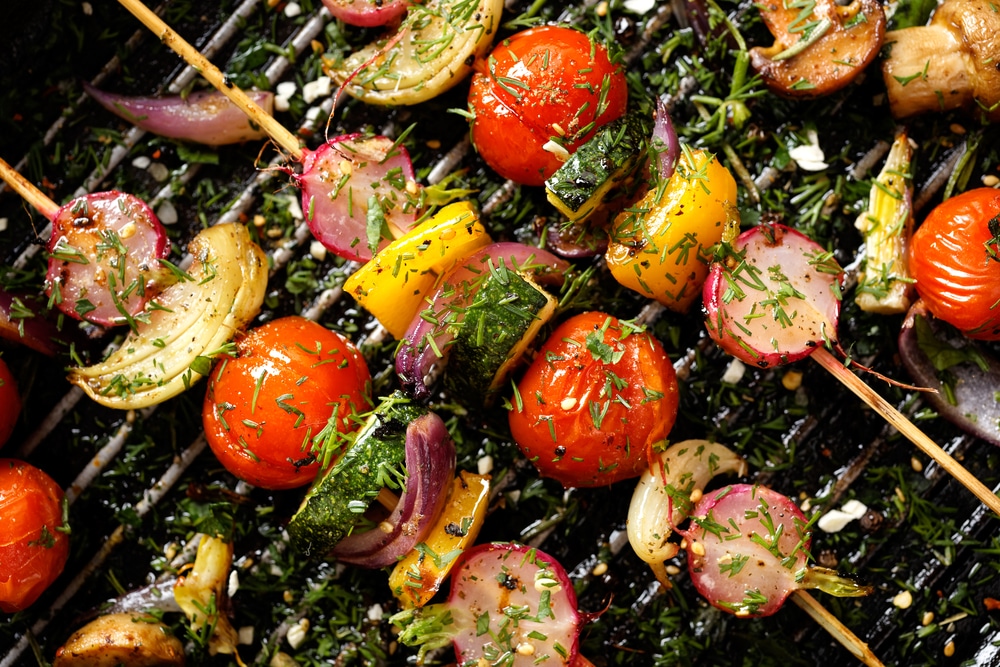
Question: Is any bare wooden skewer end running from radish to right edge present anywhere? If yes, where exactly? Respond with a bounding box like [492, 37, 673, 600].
[810, 347, 1000, 514]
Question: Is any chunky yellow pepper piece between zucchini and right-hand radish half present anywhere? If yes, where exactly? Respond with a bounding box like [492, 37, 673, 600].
[605, 147, 739, 312]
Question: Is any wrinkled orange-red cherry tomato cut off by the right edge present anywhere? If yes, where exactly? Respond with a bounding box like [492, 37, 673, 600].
[910, 188, 1000, 340]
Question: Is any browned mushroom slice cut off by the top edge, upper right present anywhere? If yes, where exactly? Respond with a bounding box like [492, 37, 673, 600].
[750, 0, 885, 97]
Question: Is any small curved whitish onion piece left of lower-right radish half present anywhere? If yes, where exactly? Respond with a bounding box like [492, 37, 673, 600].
[627, 440, 747, 587]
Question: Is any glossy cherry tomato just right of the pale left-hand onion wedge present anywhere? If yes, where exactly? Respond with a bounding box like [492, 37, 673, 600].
[202, 316, 371, 489]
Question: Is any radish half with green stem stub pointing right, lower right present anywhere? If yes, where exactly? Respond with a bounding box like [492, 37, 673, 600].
[678, 484, 872, 617]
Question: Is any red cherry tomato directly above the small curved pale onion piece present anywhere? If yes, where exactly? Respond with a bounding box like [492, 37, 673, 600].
[509, 312, 678, 486]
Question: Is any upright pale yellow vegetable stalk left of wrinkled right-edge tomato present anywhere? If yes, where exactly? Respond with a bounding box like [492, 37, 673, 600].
[854, 130, 915, 315]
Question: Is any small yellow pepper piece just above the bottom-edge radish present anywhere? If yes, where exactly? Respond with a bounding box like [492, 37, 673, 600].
[389, 470, 490, 609]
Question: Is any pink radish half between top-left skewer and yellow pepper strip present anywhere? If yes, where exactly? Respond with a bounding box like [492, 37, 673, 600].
[292, 134, 417, 262]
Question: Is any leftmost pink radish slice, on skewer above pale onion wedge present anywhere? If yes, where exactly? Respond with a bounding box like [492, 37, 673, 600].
[45, 190, 169, 326]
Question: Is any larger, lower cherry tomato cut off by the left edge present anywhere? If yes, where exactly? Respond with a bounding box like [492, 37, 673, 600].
[0, 459, 69, 614]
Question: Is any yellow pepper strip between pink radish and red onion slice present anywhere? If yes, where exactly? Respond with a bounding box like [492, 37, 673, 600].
[344, 202, 492, 338]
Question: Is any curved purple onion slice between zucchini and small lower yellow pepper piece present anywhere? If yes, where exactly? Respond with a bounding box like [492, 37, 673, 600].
[331, 412, 455, 569]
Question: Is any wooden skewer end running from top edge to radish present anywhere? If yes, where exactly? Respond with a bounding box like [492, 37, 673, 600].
[118, 0, 303, 160]
